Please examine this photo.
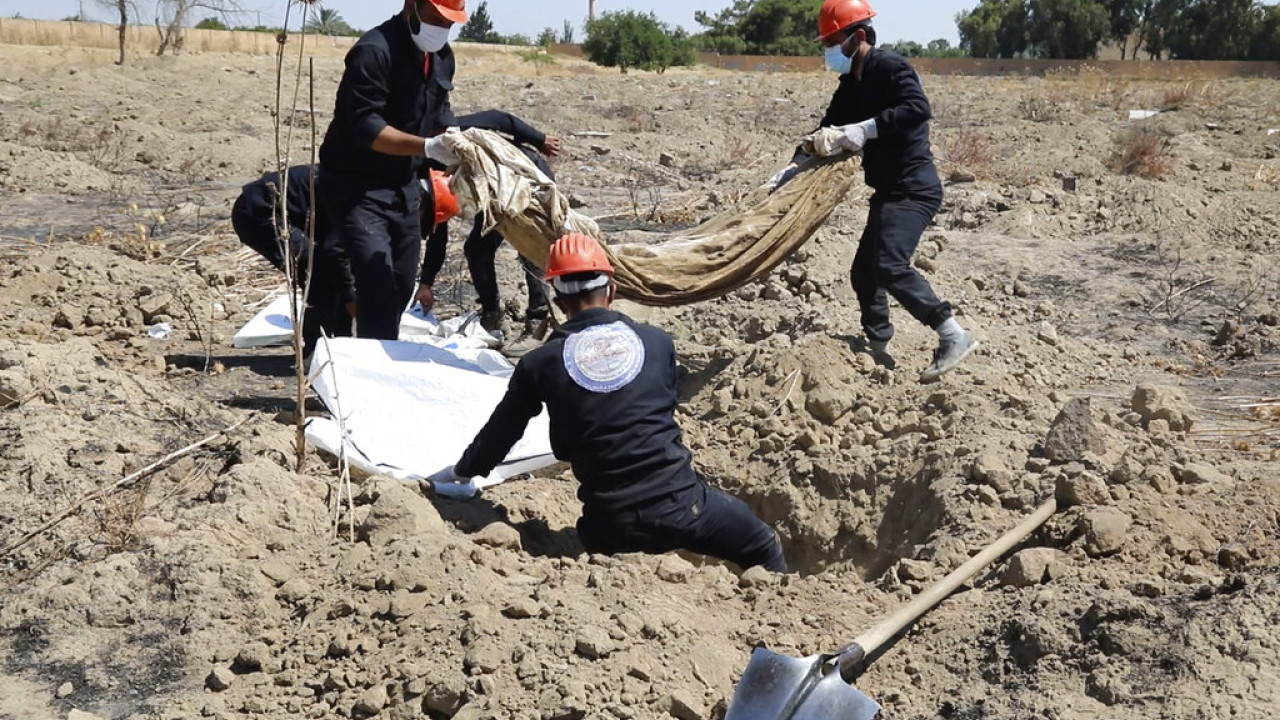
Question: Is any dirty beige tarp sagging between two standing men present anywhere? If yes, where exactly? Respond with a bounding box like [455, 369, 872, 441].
[444, 129, 859, 305]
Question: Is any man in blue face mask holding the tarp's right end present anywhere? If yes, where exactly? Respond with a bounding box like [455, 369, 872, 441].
[773, 0, 978, 382]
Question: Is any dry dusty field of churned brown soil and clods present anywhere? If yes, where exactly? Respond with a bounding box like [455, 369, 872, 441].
[0, 46, 1280, 720]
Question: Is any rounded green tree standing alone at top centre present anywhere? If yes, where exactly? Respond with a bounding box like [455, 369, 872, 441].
[582, 10, 692, 72]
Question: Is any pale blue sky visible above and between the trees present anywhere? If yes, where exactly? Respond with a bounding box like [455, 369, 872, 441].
[0, 0, 978, 45]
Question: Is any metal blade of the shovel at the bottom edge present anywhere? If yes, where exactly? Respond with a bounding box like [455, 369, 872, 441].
[724, 647, 881, 720]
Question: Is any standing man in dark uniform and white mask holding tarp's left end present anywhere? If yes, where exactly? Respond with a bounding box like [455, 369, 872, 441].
[312, 0, 466, 340]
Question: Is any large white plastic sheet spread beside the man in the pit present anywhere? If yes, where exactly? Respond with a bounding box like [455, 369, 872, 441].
[307, 336, 556, 487]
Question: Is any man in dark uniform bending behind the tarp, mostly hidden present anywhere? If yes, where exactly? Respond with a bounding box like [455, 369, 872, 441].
[416, 110, 561, 333]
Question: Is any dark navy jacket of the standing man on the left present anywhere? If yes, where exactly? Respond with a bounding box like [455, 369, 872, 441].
[320, 14, 454, 191]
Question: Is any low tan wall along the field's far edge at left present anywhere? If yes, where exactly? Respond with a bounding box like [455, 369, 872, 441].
[0, 18, 356, 55]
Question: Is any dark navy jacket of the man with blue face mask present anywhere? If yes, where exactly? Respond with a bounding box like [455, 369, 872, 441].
[819, 47, 942, 193]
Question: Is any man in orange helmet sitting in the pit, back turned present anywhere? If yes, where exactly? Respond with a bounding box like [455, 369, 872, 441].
[429, 234, 786, 573]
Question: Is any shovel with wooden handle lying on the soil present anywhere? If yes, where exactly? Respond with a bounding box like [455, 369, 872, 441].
[724, 498, 1057, 720]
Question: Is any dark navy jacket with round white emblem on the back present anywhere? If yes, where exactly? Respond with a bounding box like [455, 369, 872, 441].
[454, 309, 698, 512]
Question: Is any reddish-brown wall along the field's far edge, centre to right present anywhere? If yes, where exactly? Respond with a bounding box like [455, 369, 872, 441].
[552, 45, 1280, 79]
